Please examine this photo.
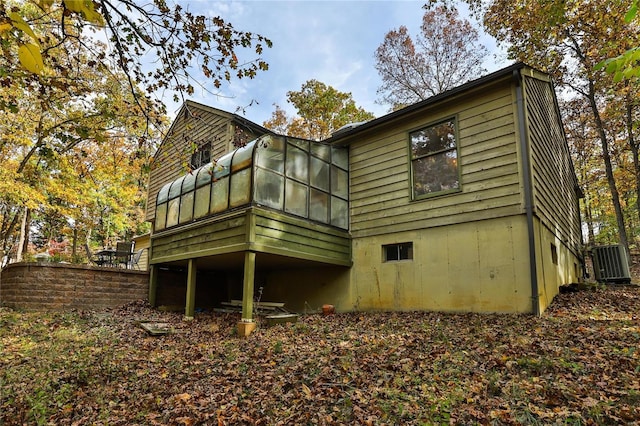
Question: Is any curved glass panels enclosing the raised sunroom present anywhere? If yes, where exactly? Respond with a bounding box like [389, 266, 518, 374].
[155, 136, 349, 231]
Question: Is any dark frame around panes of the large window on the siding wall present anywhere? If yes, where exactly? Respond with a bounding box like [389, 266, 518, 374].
[407, 114, 462, 201]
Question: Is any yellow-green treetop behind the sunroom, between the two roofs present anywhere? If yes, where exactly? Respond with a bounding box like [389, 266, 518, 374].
[263, 80, 375, 140]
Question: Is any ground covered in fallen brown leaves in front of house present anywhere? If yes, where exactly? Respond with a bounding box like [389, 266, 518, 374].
[0, 286, 640, 425]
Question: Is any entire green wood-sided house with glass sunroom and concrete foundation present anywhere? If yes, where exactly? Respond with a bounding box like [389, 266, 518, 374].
[147, 63, 583, 333]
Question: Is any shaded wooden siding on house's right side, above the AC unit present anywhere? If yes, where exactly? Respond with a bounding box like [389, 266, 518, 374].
[525, 77, 581, 251]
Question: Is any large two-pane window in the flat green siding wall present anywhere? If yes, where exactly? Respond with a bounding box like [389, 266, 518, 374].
[409, 118, 460, 199]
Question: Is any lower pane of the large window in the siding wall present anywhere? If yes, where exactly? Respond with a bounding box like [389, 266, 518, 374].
[412, 150, 460, 196]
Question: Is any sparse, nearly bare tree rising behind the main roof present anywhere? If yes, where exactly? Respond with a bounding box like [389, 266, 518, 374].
[375, 6, 487, 109]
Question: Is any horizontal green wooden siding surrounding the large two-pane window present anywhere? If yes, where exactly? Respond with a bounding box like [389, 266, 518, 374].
[350, 80, 523, 237]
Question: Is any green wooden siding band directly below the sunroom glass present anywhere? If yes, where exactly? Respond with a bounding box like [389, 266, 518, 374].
[151, 207, 351, 265]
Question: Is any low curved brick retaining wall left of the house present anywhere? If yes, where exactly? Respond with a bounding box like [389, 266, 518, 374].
[0, 263, 149, 309]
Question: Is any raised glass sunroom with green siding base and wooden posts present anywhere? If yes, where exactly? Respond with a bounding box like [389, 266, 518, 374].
[149, 135, 351, 332]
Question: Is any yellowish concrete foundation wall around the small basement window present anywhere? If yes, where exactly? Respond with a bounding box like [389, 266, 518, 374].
[351, 215, 532, 313]
